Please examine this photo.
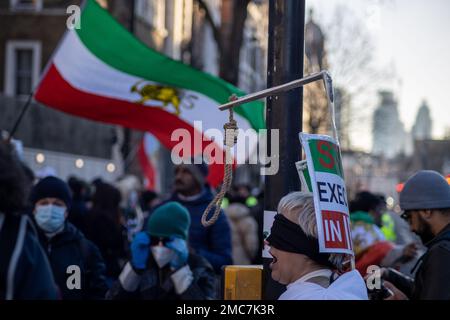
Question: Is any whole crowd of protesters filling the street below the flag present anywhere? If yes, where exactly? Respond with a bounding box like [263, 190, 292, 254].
[0, 142, 450, 300]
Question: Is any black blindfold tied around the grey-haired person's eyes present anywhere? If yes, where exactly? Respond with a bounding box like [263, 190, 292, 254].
[266, 214, 334, 268]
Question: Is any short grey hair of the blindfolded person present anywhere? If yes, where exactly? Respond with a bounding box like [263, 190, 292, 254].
[278, 192, 345, 270]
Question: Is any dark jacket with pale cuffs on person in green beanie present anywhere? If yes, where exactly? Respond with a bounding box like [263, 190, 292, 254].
[106, 253, 217, 300]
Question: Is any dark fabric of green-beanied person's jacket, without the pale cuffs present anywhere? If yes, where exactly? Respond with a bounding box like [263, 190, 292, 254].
[106, 253, 217, 300]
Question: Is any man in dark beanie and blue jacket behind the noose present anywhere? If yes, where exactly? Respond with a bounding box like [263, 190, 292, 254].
[165, 163, 233, 273]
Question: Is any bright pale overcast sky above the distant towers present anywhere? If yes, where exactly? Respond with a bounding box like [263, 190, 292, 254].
[307, 0, 450, 149]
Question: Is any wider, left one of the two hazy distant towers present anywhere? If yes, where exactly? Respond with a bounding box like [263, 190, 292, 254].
[372, 91, 407, 158]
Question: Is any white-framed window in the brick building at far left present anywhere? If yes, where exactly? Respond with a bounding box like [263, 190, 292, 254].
[5, 41, 41, 96]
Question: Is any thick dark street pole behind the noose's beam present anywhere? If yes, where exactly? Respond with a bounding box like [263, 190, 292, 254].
[263, 0, 305, 299]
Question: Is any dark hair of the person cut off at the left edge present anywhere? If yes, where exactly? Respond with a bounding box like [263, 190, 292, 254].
[0, 141, 29, 214]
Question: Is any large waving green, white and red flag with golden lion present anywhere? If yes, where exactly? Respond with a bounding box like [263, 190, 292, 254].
[34, 0, 265, 186]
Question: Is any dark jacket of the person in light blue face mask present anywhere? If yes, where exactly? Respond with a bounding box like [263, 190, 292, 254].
[39, 222, 108, 300]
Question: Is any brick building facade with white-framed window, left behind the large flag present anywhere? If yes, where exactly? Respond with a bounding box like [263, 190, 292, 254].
[0, 0, 120, 180]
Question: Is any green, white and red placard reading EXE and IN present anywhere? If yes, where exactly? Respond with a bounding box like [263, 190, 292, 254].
[300, 133, 353, 255]
